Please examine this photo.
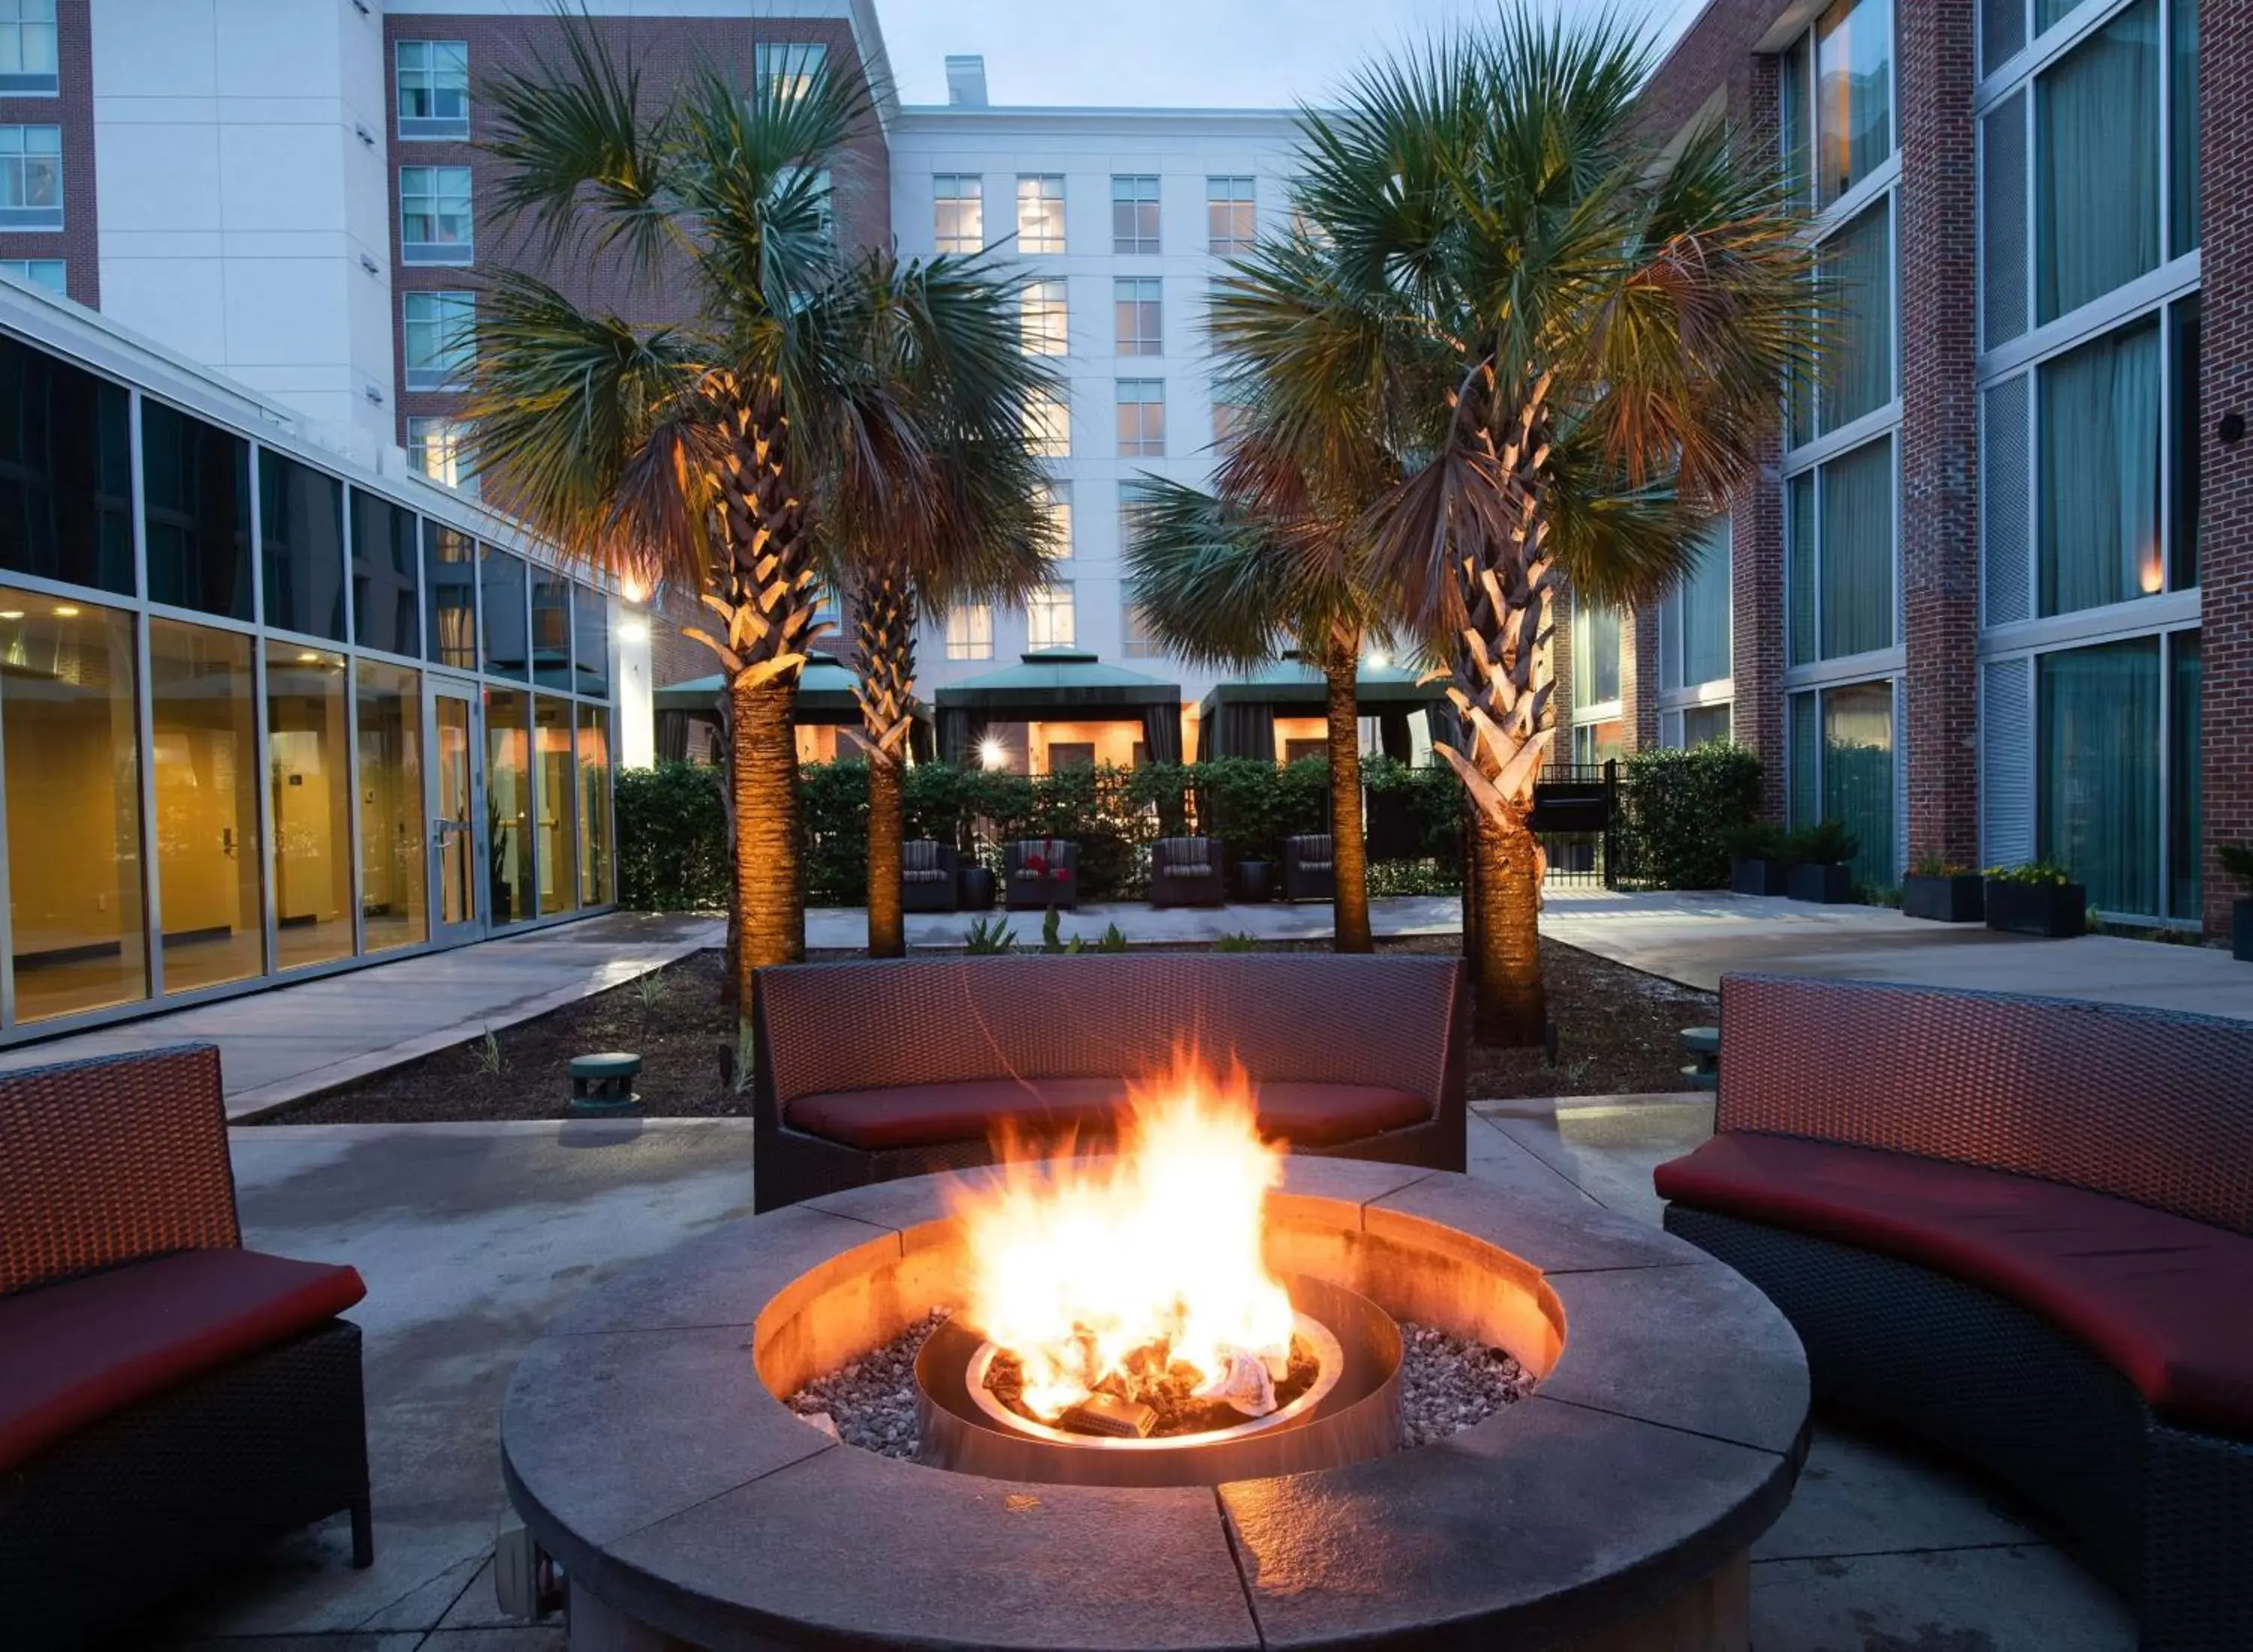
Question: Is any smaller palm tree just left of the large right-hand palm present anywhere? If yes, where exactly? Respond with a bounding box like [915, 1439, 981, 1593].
[1126, 478, 1386, 951]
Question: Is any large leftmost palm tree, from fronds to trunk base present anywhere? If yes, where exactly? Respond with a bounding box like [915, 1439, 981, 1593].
[469, 20, 1054, 1003]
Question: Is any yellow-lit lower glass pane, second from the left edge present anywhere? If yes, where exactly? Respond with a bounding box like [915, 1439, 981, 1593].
[149, 620, 266, 994]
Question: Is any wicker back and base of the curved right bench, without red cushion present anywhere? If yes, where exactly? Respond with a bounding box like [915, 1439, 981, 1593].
[1665, 976, 2253, 1652]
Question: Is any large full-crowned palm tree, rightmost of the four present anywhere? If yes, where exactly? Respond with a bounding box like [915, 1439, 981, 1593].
[1212, 7, 1818, 1044]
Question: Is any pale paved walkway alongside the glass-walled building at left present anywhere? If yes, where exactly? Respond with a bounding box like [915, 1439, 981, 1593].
[0, 913, 721, 1118]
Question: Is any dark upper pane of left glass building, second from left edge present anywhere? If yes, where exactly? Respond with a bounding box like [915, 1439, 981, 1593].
[142, 399, 252, 620]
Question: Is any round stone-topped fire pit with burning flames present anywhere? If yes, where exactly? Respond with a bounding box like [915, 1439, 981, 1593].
[502, 1063, 1807, 1652]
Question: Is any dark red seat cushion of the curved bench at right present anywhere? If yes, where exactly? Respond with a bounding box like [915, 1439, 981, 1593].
[1656, 1132, 2253, 1438]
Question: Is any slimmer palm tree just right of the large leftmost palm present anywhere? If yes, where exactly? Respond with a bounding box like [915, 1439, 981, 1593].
[818, 255, 1052, 958]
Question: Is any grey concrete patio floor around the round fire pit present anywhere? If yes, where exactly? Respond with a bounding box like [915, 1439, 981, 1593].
[140, 1098, 2136, 1652]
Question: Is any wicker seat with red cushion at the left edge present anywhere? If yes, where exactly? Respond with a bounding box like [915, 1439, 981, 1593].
[0, 1044, 374, 1647]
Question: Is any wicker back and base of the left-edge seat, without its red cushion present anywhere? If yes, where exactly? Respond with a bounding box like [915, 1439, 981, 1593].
[0, 1046, 374, 1647]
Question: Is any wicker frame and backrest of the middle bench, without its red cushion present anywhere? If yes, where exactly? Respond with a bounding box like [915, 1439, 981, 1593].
[753, 954, 1467, 1210]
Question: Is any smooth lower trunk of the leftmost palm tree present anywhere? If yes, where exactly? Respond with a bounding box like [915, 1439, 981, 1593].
[730, 671, 807, 1008]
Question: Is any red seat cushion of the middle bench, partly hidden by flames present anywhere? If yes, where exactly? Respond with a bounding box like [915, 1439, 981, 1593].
[784, 1078, 1431, 1152]
